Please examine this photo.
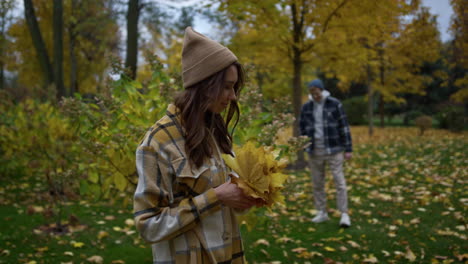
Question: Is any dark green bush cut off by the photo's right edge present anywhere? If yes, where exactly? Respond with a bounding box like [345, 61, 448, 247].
[437, 105, 467, 132]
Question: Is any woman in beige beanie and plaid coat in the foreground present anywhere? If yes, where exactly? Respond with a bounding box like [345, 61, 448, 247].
[134, 27, 256, 263]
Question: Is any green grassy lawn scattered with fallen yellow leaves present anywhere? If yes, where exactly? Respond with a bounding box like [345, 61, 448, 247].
[0, 127, 468, 263]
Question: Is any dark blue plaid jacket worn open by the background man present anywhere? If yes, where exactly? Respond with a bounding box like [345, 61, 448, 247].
[299, 96, 353, 155]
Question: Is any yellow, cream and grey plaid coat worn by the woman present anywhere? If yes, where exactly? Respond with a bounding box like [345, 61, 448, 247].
[134, 105, 244, 264]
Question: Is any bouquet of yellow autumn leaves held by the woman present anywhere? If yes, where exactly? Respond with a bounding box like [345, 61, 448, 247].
[223, 142, 288, 207]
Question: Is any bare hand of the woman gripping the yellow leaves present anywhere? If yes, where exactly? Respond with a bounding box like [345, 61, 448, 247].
[214, 182, 263, 210]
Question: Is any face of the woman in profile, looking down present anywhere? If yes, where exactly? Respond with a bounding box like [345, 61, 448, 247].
[208, 65, 238, 113]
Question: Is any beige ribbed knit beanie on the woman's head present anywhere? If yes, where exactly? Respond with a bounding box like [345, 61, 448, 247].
[182, 27, 237, 89]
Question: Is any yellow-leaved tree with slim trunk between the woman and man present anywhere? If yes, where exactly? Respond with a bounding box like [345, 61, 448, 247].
[214, 0, 348, 164]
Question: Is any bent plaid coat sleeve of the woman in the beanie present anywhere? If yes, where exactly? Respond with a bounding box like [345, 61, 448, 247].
[134, 140, 220, 243]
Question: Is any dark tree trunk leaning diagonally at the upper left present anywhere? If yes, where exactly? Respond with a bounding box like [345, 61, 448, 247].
[24, 0, 54, 86]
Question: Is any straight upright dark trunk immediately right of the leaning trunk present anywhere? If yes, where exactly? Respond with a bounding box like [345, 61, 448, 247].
[53, 0, 64, 100]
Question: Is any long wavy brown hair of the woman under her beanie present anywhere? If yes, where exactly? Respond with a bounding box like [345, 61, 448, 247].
[174, 62, 244, 168]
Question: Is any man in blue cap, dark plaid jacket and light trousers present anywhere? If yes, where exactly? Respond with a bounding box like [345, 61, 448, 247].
[299, 79, 352, 227]
